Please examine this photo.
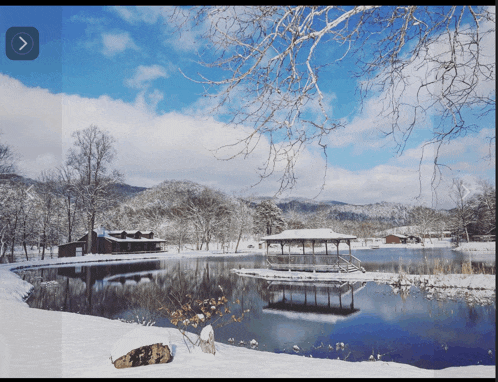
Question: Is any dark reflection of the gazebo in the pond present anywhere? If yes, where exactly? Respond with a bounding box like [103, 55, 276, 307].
[263, 281, 366, 320]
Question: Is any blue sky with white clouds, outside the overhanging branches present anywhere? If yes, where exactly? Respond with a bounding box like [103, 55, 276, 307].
[0, 7, 495, 208]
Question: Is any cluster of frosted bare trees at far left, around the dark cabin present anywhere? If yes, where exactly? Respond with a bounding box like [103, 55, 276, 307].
[0, 125, 123, 262]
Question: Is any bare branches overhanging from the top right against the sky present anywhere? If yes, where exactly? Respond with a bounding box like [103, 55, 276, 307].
[170, 6, 495, 191]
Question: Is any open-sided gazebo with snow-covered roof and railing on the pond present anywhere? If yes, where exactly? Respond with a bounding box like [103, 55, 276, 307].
[261, 228, 364, 273]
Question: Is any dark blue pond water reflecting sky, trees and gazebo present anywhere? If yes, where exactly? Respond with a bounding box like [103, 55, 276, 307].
[15, 249, 496, 369]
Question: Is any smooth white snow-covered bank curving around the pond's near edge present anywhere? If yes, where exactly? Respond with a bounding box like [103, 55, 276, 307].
[0, 251, 496, 378]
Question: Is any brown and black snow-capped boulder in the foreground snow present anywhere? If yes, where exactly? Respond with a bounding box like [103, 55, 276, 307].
[114, 343, 172, 369]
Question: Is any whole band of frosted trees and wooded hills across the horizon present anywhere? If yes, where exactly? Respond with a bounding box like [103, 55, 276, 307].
[0, 125, 496, 262]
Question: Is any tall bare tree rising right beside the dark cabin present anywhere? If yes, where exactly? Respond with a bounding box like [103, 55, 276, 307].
[67, 125, 122, 253]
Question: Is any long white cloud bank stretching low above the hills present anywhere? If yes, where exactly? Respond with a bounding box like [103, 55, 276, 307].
[0, 74, 494, 204]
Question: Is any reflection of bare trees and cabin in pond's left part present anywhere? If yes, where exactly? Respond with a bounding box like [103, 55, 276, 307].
[22, 258, 268, 321]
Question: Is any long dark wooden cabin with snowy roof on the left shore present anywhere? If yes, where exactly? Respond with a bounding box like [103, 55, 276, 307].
[59, 229, 166, 257]
